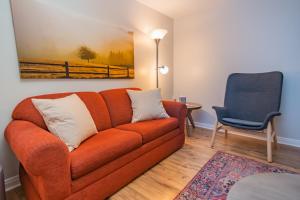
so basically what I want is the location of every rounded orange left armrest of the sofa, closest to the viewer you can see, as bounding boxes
[5,120,71,200]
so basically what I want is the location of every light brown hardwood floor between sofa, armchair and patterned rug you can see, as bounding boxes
[7,128,300,200]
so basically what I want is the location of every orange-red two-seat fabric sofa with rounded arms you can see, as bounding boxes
[5,88,186,200]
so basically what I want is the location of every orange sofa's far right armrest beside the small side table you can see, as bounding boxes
[162,101,187,133]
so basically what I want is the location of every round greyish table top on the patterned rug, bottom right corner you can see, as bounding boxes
[227,173,300,200]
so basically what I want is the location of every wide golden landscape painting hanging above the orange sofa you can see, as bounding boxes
[11,0,134,79]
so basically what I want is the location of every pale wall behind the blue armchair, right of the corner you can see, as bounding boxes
[174,0,300,141]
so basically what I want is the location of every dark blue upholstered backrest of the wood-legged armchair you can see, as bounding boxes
[224,72,283,122]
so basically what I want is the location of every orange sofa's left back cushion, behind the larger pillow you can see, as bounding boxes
[12,92,111,131]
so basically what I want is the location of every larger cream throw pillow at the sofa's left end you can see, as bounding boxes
[32,94,98,151]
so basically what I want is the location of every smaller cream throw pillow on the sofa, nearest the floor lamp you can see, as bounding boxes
[127,89,169,123]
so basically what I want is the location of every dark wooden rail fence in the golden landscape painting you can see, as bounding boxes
[19,61,130,78]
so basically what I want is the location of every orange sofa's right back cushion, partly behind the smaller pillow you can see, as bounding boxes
[100,88,141,127]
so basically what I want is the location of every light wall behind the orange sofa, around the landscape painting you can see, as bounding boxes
[0,0,173,178]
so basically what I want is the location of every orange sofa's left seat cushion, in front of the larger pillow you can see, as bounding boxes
[70,128,142,179]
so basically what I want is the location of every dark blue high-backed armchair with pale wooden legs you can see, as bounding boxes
[211,72,283,162]
